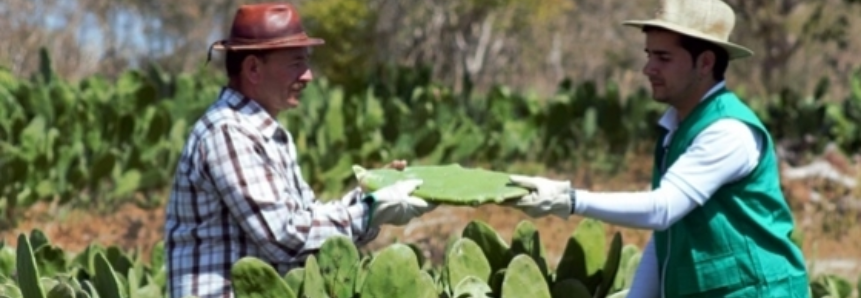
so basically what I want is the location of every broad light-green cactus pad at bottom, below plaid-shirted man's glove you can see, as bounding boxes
[360,243,437,298]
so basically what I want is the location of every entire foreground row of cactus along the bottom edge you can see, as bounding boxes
[0,225,861,298]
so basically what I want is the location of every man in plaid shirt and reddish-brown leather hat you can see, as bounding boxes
[165,3,435,298]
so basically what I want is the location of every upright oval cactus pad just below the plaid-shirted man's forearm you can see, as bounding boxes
[317,236,359,298]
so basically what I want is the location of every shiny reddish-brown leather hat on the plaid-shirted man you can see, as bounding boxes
[210,3,324,51]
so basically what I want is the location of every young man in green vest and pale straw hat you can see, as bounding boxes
[504,0,808,298]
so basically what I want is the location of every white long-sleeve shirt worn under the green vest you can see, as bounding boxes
[574,82,762,298]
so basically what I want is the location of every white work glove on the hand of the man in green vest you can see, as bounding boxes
[506,175,571,219]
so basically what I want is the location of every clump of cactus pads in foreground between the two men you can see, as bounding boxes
[234,221,636,298]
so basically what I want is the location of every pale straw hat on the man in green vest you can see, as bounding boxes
[622,0,753,59]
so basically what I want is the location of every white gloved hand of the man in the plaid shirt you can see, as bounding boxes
[366,179,436,227]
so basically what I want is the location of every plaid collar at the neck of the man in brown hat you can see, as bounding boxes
[218,87,283,137]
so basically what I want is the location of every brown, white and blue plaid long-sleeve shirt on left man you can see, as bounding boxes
[165,88,379,298]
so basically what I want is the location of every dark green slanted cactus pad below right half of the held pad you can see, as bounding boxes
[461,220,512,272]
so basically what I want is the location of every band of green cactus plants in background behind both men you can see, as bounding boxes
[0,51,861,228]
